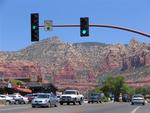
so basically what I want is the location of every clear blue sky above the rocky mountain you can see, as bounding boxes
[0,0,150,51]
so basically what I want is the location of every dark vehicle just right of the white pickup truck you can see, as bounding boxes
[88,93,102,103]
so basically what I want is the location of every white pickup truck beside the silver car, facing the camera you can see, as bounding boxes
[59,90,84,105]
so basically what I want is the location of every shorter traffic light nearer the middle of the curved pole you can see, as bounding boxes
[80,17,89,37]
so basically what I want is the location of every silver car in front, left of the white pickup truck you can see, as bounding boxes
[32,93,58,108]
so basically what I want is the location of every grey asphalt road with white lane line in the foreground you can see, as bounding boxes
[0,103,150,113]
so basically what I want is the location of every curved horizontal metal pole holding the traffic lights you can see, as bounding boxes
[39,24,150,38]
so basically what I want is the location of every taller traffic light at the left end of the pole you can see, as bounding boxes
[31,13,39,42]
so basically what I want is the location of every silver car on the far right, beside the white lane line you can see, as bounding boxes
[131,94,145,105]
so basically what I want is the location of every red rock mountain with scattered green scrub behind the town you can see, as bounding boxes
[0,37,150,90]
